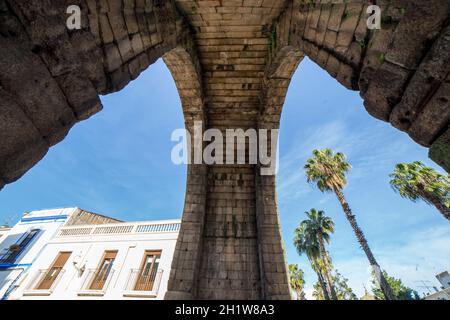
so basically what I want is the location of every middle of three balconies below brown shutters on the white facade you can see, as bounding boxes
[78,268,114,296]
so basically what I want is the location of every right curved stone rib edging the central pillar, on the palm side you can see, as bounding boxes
[251,46,304,299]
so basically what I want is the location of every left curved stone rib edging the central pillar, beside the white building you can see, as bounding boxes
[163,46,208,299]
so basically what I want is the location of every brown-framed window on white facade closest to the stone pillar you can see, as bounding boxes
[134,251,161,291]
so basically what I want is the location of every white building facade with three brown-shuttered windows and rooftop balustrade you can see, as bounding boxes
[8,220,181,300]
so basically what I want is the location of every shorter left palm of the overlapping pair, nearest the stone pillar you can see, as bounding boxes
[294,225,330,300]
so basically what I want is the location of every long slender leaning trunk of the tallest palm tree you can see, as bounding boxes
[334,188,397,300]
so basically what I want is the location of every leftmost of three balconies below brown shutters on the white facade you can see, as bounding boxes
[23,268,65,296]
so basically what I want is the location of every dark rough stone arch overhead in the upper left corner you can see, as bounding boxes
[0,0,185,189]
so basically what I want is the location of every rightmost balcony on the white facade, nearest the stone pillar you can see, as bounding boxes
[123,269,163,298]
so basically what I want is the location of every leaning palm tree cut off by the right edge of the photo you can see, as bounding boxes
[389,161,450,221]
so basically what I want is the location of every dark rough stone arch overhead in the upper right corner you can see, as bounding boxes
[275,0,450,171]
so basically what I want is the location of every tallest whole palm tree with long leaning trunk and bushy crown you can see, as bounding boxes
[304,149,395,300]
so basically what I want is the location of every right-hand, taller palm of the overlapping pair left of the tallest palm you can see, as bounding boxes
[300,209,337,300]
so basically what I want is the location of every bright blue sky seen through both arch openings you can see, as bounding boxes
[0,59,450,295]
